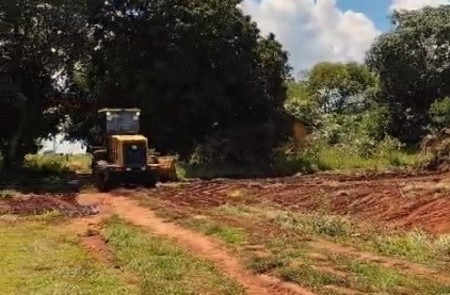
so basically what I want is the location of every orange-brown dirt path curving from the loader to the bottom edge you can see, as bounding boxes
[78,194,314,295]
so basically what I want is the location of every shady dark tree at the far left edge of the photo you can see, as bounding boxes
[0,0,88,169]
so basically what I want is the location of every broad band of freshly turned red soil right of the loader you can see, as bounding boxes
[134,174,450,234]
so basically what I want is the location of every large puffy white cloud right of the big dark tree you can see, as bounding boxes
[241,0,380,73]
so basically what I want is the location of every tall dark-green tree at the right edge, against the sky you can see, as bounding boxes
[367,5,450,143]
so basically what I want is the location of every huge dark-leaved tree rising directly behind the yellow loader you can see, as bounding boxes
[70,0,290,162]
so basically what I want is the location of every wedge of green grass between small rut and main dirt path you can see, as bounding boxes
[106,217,243,295]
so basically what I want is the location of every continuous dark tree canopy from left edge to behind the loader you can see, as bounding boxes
[0,0,290,169]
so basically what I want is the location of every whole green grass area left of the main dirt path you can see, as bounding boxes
[0,214,242,295]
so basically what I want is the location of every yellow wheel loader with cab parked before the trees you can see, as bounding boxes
[91,109,176,191]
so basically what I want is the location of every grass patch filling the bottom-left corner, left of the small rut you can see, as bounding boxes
[0,216,137,295]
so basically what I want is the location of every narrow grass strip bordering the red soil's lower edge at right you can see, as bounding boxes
[260,210,450,267]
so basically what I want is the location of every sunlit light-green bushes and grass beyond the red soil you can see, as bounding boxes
[278,108,415,173]
